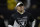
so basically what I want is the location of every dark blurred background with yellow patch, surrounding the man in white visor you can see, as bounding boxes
[0,0,40,27]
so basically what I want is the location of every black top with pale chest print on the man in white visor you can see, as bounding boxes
[9,11,34,27]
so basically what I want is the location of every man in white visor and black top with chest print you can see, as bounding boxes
[8,2,34,27]
